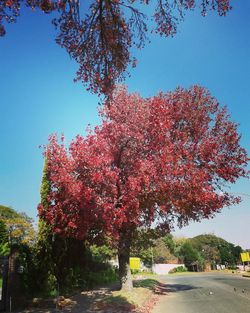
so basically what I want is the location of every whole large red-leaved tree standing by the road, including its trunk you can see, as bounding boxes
[39,86,248,289]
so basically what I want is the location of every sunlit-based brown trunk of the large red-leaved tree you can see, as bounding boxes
[118,232,133,291]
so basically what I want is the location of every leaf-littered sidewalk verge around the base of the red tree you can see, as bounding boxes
[16,278,162,313]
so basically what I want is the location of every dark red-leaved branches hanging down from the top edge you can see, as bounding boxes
[0,0,231,95]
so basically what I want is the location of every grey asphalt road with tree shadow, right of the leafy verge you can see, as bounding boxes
[153,273,250,313]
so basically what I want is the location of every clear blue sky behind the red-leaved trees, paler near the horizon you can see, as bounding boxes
[0,0,250,248]
